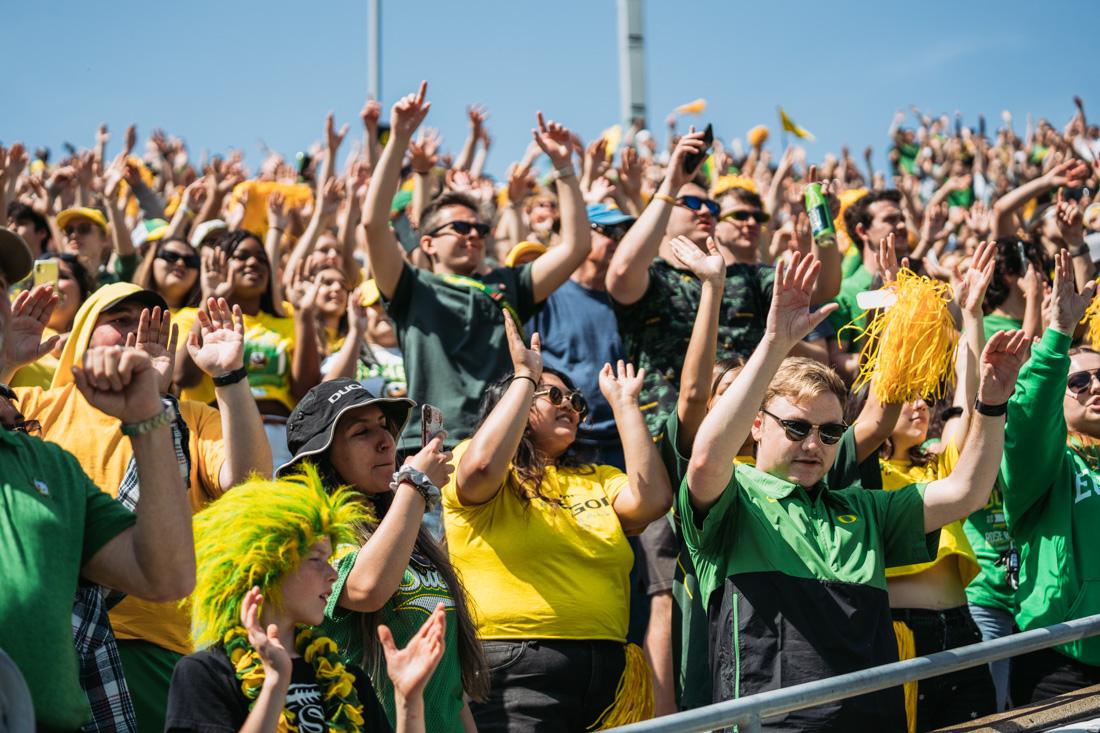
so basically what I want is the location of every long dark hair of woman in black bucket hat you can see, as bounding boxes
[305,453,488,701]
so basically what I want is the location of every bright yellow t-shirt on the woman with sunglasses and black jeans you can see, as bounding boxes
[442,440,634,642]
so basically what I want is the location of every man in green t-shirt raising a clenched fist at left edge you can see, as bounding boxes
[0,228,195,731]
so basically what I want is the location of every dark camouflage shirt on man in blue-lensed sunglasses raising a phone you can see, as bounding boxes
[615,258,776,436]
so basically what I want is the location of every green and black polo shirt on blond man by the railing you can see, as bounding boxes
[678,464,939,730]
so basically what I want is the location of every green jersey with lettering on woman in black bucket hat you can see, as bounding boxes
[321,539,465,733]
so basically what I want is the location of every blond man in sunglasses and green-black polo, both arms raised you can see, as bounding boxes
[678,253,1027,731]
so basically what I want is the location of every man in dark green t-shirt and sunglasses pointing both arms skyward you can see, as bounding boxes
[363,83,592,451]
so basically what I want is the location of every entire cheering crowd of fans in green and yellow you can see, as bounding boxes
[0,85,1100,732]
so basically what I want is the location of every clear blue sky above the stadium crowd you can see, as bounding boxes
[0,0,1100,175]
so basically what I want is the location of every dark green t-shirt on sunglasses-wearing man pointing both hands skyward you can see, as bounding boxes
[385,259,536,450]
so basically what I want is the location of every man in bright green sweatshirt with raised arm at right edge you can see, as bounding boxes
[1001,250,1100,704]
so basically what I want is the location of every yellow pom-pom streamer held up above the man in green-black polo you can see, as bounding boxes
[842,269,959,404]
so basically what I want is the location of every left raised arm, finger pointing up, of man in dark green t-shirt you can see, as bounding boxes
[363,81,431,299]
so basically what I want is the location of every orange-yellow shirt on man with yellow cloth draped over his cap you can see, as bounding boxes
[15,382,226,654]
